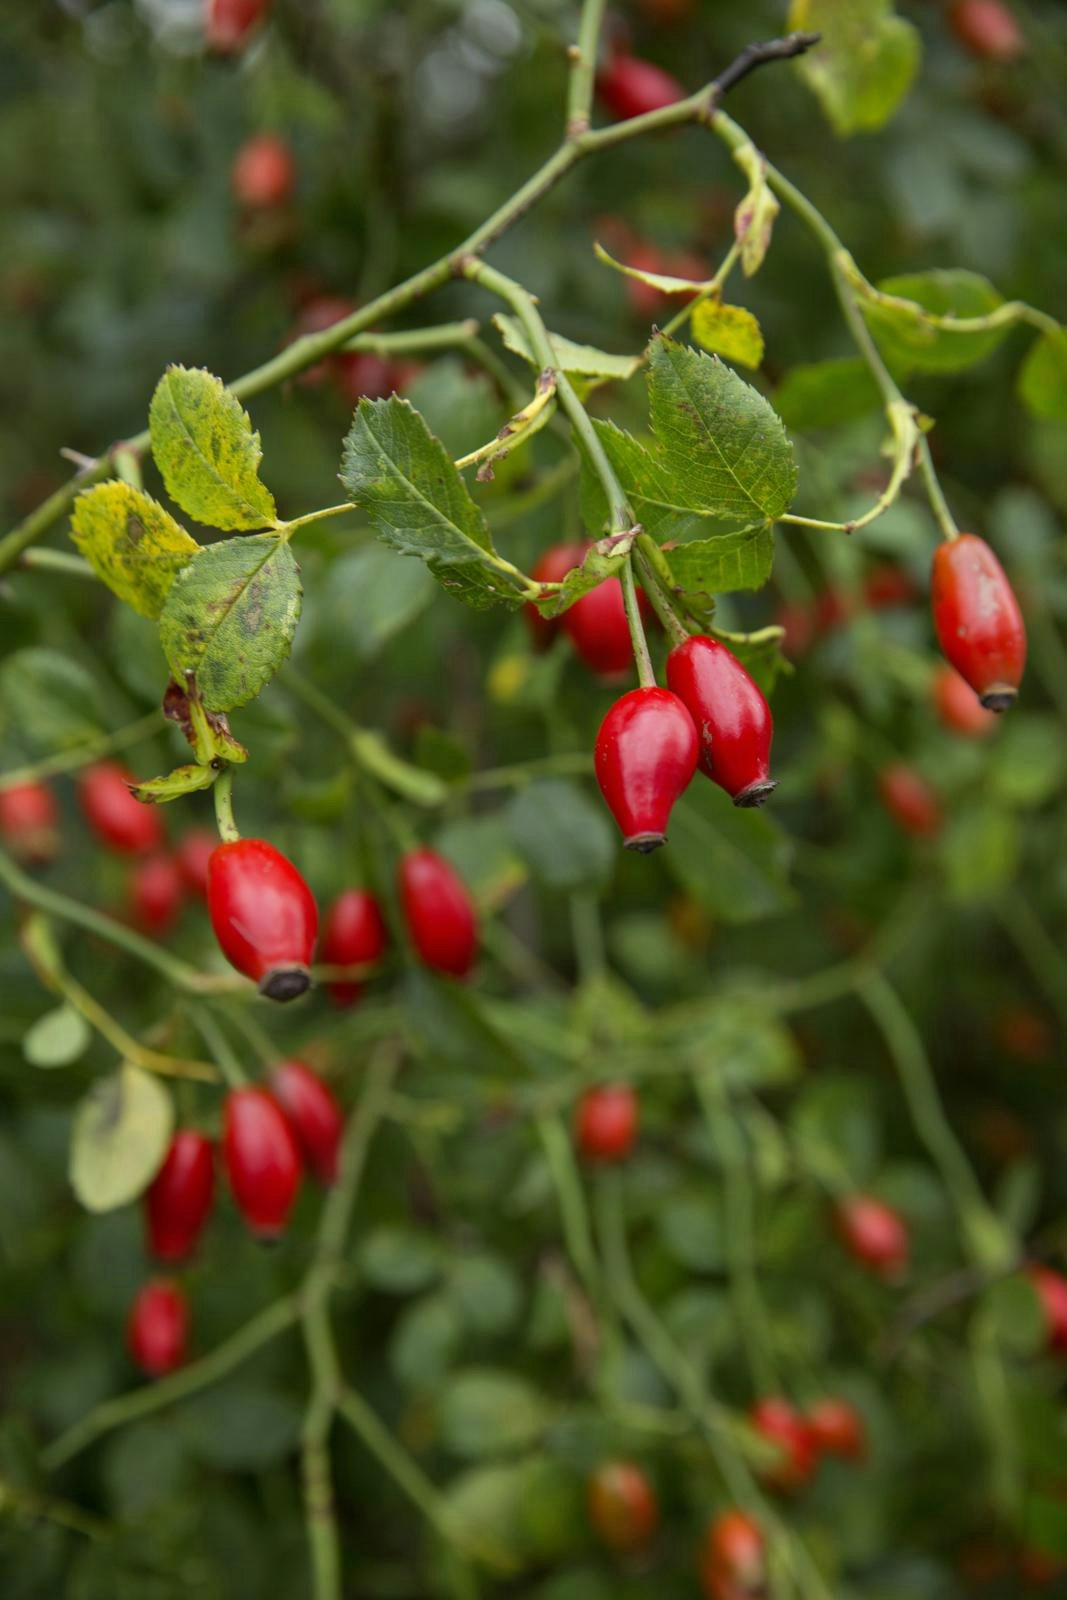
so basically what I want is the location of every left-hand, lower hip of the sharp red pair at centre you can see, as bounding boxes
[595,688,699,854]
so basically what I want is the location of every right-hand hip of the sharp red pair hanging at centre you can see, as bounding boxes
[667,635,777,806]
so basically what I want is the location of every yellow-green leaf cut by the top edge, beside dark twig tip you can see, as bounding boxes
[789,0,921,136]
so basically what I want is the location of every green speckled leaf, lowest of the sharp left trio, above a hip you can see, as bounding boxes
[160,538,301,710]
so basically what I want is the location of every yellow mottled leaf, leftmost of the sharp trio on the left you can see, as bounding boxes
[70,480,200,618]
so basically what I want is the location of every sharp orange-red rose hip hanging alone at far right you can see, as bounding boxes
[929,533,1027,710]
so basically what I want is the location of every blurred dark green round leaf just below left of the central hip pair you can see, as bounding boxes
[507,778,616,893]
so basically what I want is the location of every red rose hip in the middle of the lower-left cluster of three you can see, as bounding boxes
[222,1088,301,1238]
